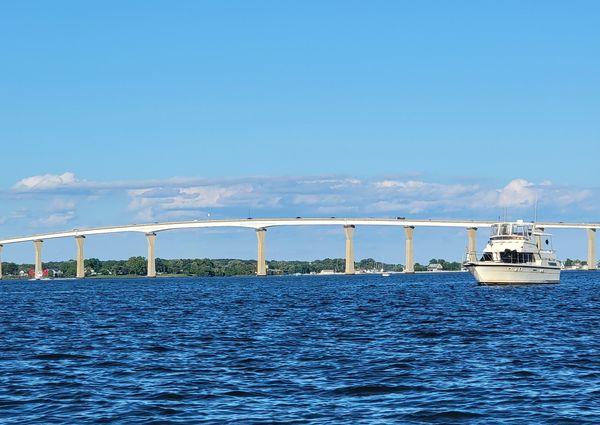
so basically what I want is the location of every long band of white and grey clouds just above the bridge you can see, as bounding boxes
[4,172,600,227]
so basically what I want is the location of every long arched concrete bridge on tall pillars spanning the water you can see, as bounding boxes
[0,217,600,278]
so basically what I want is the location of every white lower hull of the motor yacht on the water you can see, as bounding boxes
[466,262,560,285]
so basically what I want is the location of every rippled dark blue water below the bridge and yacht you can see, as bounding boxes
[0,272,600,424]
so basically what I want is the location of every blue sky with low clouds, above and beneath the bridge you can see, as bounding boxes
[0,0,600,263]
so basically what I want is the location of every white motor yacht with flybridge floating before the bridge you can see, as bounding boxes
[464,220,561,284]
